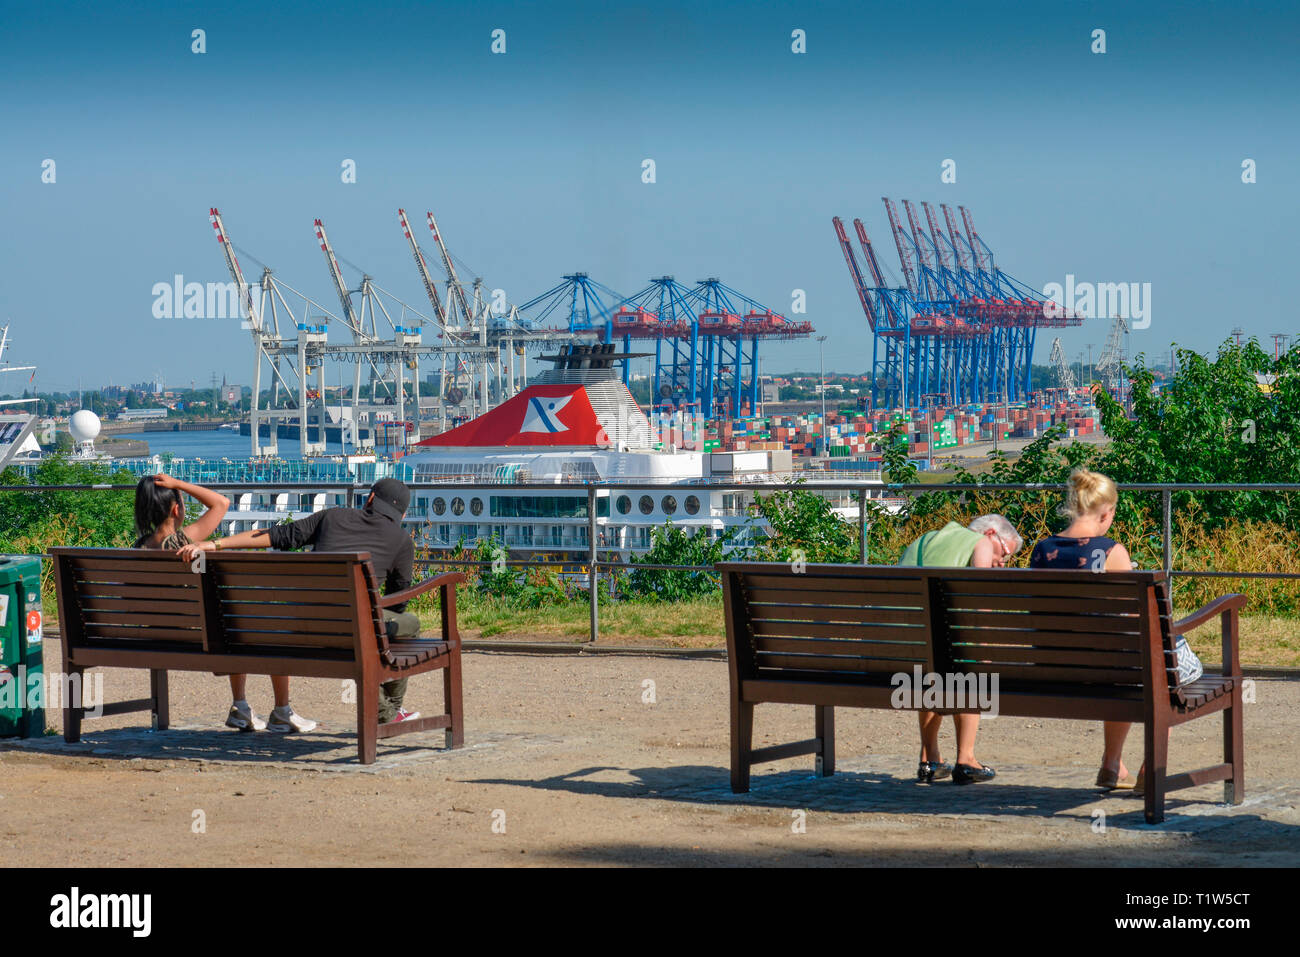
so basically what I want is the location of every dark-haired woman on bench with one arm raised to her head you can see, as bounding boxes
[135,475,316,733]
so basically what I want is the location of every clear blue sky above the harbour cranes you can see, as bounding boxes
[0,0,1300,389]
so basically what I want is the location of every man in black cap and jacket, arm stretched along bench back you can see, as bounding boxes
[181,479,420,724]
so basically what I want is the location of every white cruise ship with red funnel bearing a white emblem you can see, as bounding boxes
[169,345,891,560]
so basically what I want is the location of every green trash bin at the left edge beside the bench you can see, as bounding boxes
[0,555,47,737]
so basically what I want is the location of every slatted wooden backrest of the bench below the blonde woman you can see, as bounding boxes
[718,563,1173,694]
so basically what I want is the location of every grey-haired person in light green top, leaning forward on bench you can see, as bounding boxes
[898,515,1024,784]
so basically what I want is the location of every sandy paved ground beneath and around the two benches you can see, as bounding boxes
[0,642,1300,867]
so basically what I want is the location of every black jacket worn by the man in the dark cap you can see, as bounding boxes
[267,507,415,611]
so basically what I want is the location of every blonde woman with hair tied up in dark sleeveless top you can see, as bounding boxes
[1030,468,1203,793]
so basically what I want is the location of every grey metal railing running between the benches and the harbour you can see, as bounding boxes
[0,475,1300,644]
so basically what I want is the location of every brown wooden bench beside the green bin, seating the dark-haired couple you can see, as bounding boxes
[51,549,464,765]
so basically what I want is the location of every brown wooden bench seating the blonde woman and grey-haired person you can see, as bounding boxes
[716,563,1247,823]
